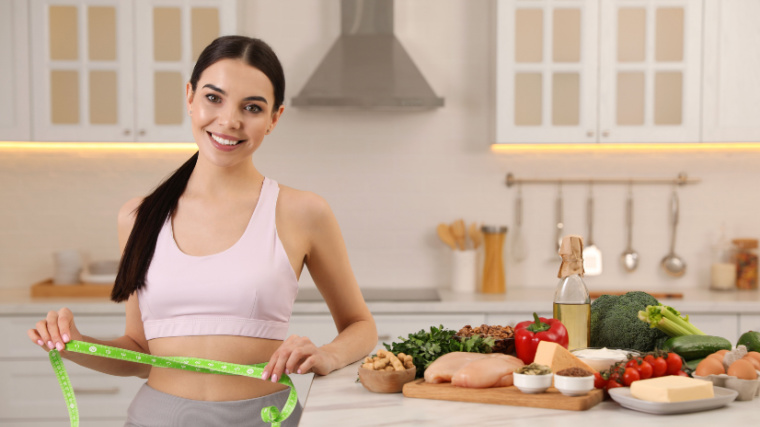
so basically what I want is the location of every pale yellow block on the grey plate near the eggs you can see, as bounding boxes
[631,375,715,402]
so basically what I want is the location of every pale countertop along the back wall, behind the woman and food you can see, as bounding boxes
[0,288,760,315]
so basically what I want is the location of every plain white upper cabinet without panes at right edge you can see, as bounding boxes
[702,0,760,142]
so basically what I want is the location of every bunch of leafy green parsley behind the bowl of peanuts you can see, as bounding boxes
[383,325,494,378]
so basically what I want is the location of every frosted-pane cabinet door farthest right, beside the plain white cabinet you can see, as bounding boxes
[599,0,702,142]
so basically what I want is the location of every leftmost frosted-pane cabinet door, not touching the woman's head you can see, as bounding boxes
[31,0,134,141]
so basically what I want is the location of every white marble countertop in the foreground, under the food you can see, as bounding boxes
[299,362,760,427]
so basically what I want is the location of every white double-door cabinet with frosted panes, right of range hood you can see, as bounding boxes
[495,0,702,143]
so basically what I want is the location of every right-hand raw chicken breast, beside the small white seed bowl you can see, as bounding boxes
[451,354,524,388]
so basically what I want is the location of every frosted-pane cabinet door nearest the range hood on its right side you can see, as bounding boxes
[495,0,598,143]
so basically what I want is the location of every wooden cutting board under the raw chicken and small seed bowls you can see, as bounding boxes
[403,378,604,411]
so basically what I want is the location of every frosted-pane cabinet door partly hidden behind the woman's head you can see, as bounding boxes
[135,0,237,142]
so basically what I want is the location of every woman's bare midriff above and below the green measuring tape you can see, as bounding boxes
[148,335,287,401]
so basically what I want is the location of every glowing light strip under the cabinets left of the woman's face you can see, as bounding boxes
[0,141,198,151]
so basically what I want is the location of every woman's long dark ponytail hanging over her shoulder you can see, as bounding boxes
[111,152,198,302]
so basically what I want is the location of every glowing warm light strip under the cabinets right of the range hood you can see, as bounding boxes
[491,142,760,153]
